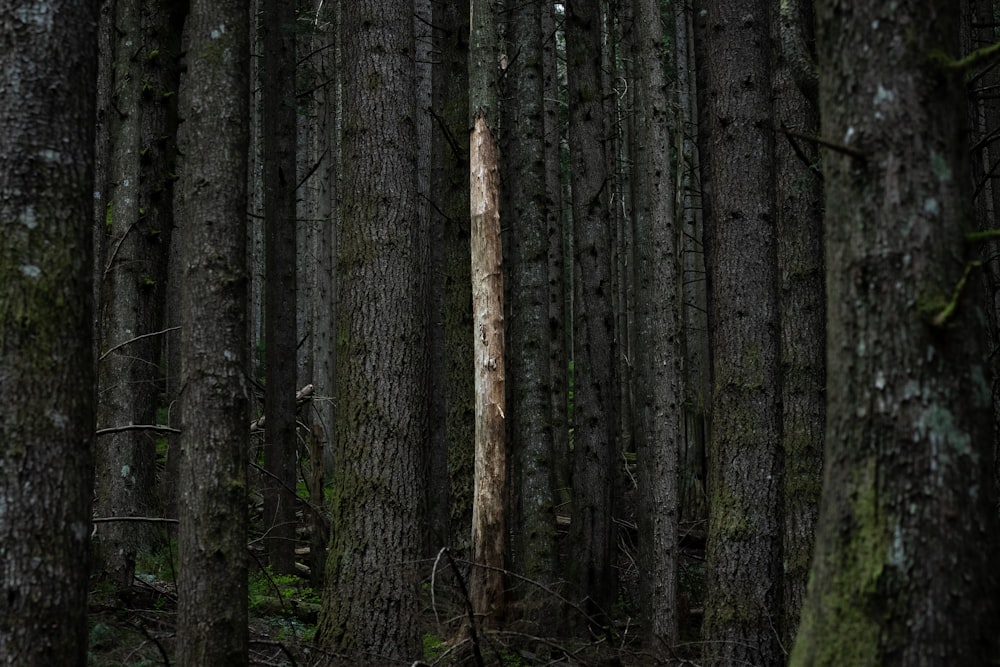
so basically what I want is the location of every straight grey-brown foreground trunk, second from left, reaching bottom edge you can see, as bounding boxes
[177,0,250,665]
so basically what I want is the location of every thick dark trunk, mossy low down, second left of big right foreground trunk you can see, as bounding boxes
[699,0,784,665]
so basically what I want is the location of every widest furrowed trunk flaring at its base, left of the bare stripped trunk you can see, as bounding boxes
[317,0,427,664]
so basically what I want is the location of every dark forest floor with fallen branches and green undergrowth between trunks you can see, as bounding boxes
[88,524,703,667]
